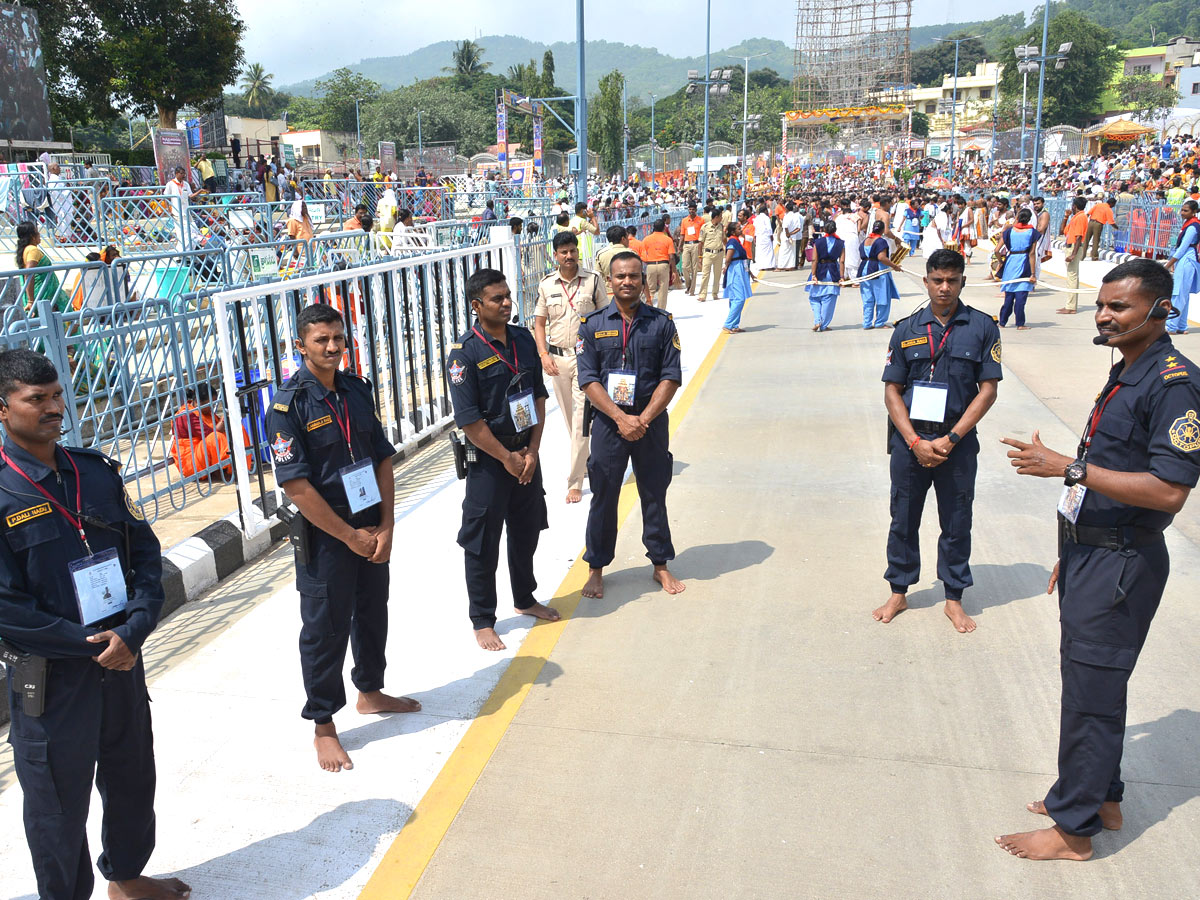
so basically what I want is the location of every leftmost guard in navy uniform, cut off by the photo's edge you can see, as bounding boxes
[0,349,188,900]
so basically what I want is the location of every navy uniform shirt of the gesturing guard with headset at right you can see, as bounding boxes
[1076,335,1200,530]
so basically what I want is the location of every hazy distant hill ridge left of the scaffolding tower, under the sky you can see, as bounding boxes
[280,35,794,96]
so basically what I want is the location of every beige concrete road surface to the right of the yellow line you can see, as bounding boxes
[409,266,1200,900]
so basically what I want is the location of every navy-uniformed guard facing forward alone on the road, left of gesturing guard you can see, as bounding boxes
[871,250,1003,634]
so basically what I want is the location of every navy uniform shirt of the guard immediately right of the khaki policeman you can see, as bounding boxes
[576,300,683,415]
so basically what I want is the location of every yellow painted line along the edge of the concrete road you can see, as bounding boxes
[359,331,730,900]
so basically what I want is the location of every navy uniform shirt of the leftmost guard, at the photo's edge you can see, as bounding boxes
[0,442,164,659]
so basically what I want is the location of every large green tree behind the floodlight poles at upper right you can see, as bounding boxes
[1000,6,1122,127]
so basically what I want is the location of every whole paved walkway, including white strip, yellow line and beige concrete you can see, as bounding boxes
[0,260,1200,900]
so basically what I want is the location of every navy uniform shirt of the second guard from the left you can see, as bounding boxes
[266,364,396,514]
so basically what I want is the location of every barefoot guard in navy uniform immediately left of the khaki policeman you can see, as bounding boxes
[446,269,559,650]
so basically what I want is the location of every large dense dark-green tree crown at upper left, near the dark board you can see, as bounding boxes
[90,0,246,128]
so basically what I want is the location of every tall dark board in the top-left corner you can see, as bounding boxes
[0,4,54,142]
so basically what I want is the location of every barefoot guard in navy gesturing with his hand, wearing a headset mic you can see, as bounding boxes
[996,259,1200,859]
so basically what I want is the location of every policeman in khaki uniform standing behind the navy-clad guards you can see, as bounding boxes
[533,232,604,503]
